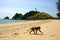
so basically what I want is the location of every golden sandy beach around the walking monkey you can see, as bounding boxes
[0,20,60,40]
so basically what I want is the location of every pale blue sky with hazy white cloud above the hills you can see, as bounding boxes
[0,0,58,19]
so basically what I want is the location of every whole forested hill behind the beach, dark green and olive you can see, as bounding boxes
[12,11,52,20]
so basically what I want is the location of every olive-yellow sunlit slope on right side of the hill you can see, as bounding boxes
[27,12,52,20]
